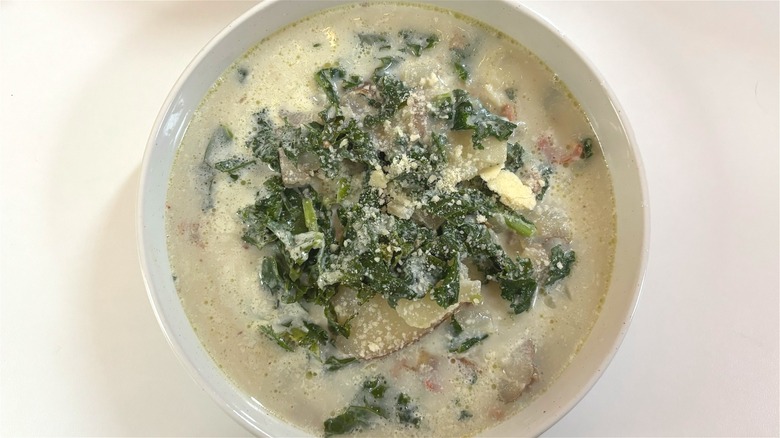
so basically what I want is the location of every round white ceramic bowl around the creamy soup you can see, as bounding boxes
[138,0,649,436]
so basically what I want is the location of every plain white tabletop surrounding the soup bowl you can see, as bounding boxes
[0,0,780,436]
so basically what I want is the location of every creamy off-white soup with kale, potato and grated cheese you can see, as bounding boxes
[166,3,615,437]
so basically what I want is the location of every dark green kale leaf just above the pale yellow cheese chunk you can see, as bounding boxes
[452,90,517,149]
